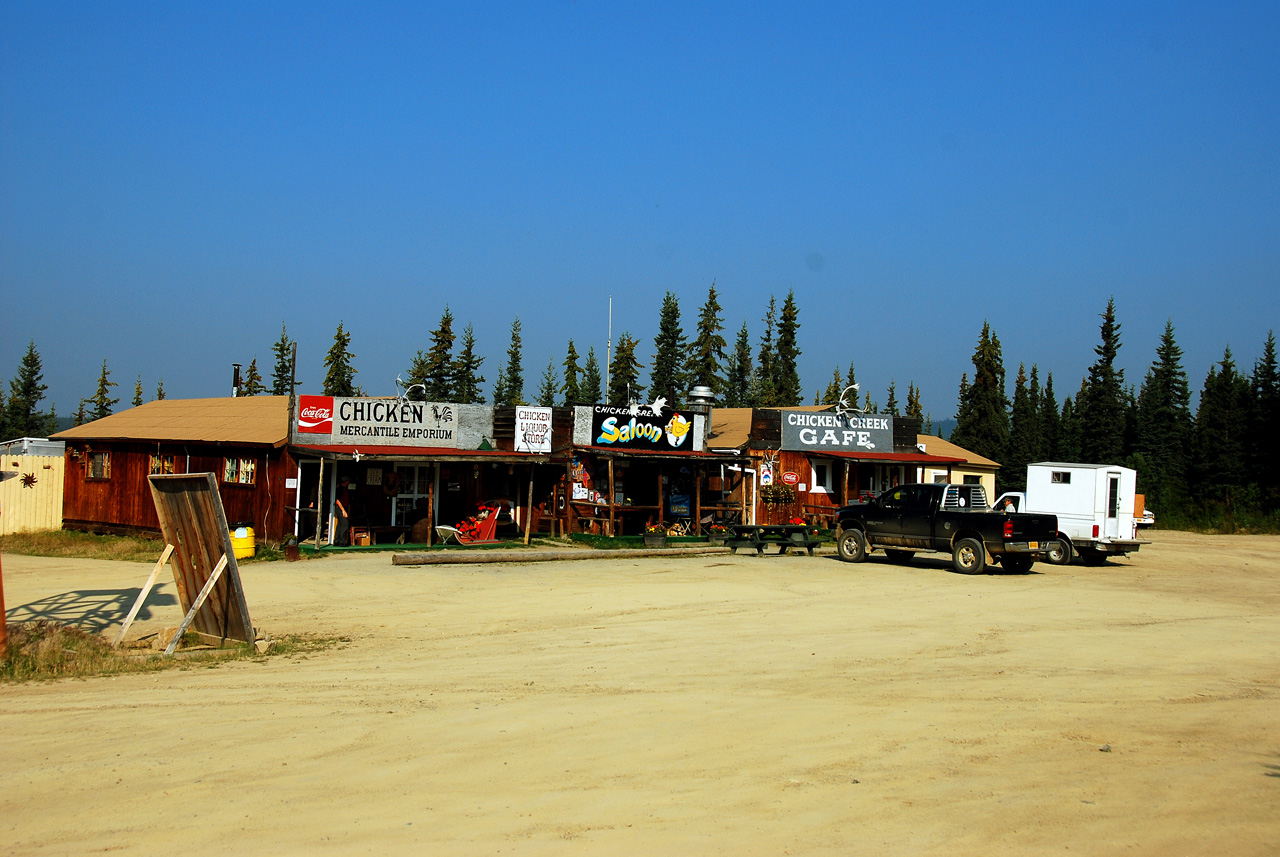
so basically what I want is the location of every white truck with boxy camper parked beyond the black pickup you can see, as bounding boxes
[996,462,1151,565]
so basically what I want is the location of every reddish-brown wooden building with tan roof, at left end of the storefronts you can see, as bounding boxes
[52,395,297,541]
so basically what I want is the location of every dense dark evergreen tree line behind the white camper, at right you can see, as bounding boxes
[951,298,1280,531]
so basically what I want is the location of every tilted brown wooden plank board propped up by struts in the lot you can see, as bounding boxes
[148,473,253,643]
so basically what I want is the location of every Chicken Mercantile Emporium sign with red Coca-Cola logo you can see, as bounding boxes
[297,395,458,448]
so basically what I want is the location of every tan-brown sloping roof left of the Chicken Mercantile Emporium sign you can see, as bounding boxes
[52,395,289,446]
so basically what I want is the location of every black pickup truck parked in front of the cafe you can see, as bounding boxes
[836,484,1057,574]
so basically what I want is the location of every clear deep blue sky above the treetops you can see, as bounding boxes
[0,0,1280,418]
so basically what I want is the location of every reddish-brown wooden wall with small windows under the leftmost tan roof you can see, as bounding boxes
[63,440,297,541]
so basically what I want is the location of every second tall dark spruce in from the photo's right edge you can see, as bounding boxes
[1192,348,1252,527]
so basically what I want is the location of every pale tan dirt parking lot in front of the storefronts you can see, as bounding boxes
[0,532,1280,856]
